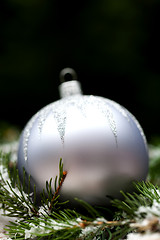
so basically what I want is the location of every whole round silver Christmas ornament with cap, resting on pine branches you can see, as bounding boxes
[18,69,148,205]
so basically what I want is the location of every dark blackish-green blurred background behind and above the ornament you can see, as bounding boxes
[0,0,160,141]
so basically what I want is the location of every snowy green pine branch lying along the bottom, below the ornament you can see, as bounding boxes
[4,209,120,240]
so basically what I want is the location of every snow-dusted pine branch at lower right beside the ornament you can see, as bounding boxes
[112,182,160,239]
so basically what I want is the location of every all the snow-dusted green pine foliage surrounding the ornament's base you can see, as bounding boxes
[0,142,160,240]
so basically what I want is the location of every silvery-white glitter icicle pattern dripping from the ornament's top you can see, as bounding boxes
[23,95,120,161]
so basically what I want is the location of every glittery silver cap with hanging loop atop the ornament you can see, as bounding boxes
[59,68,82,98]
